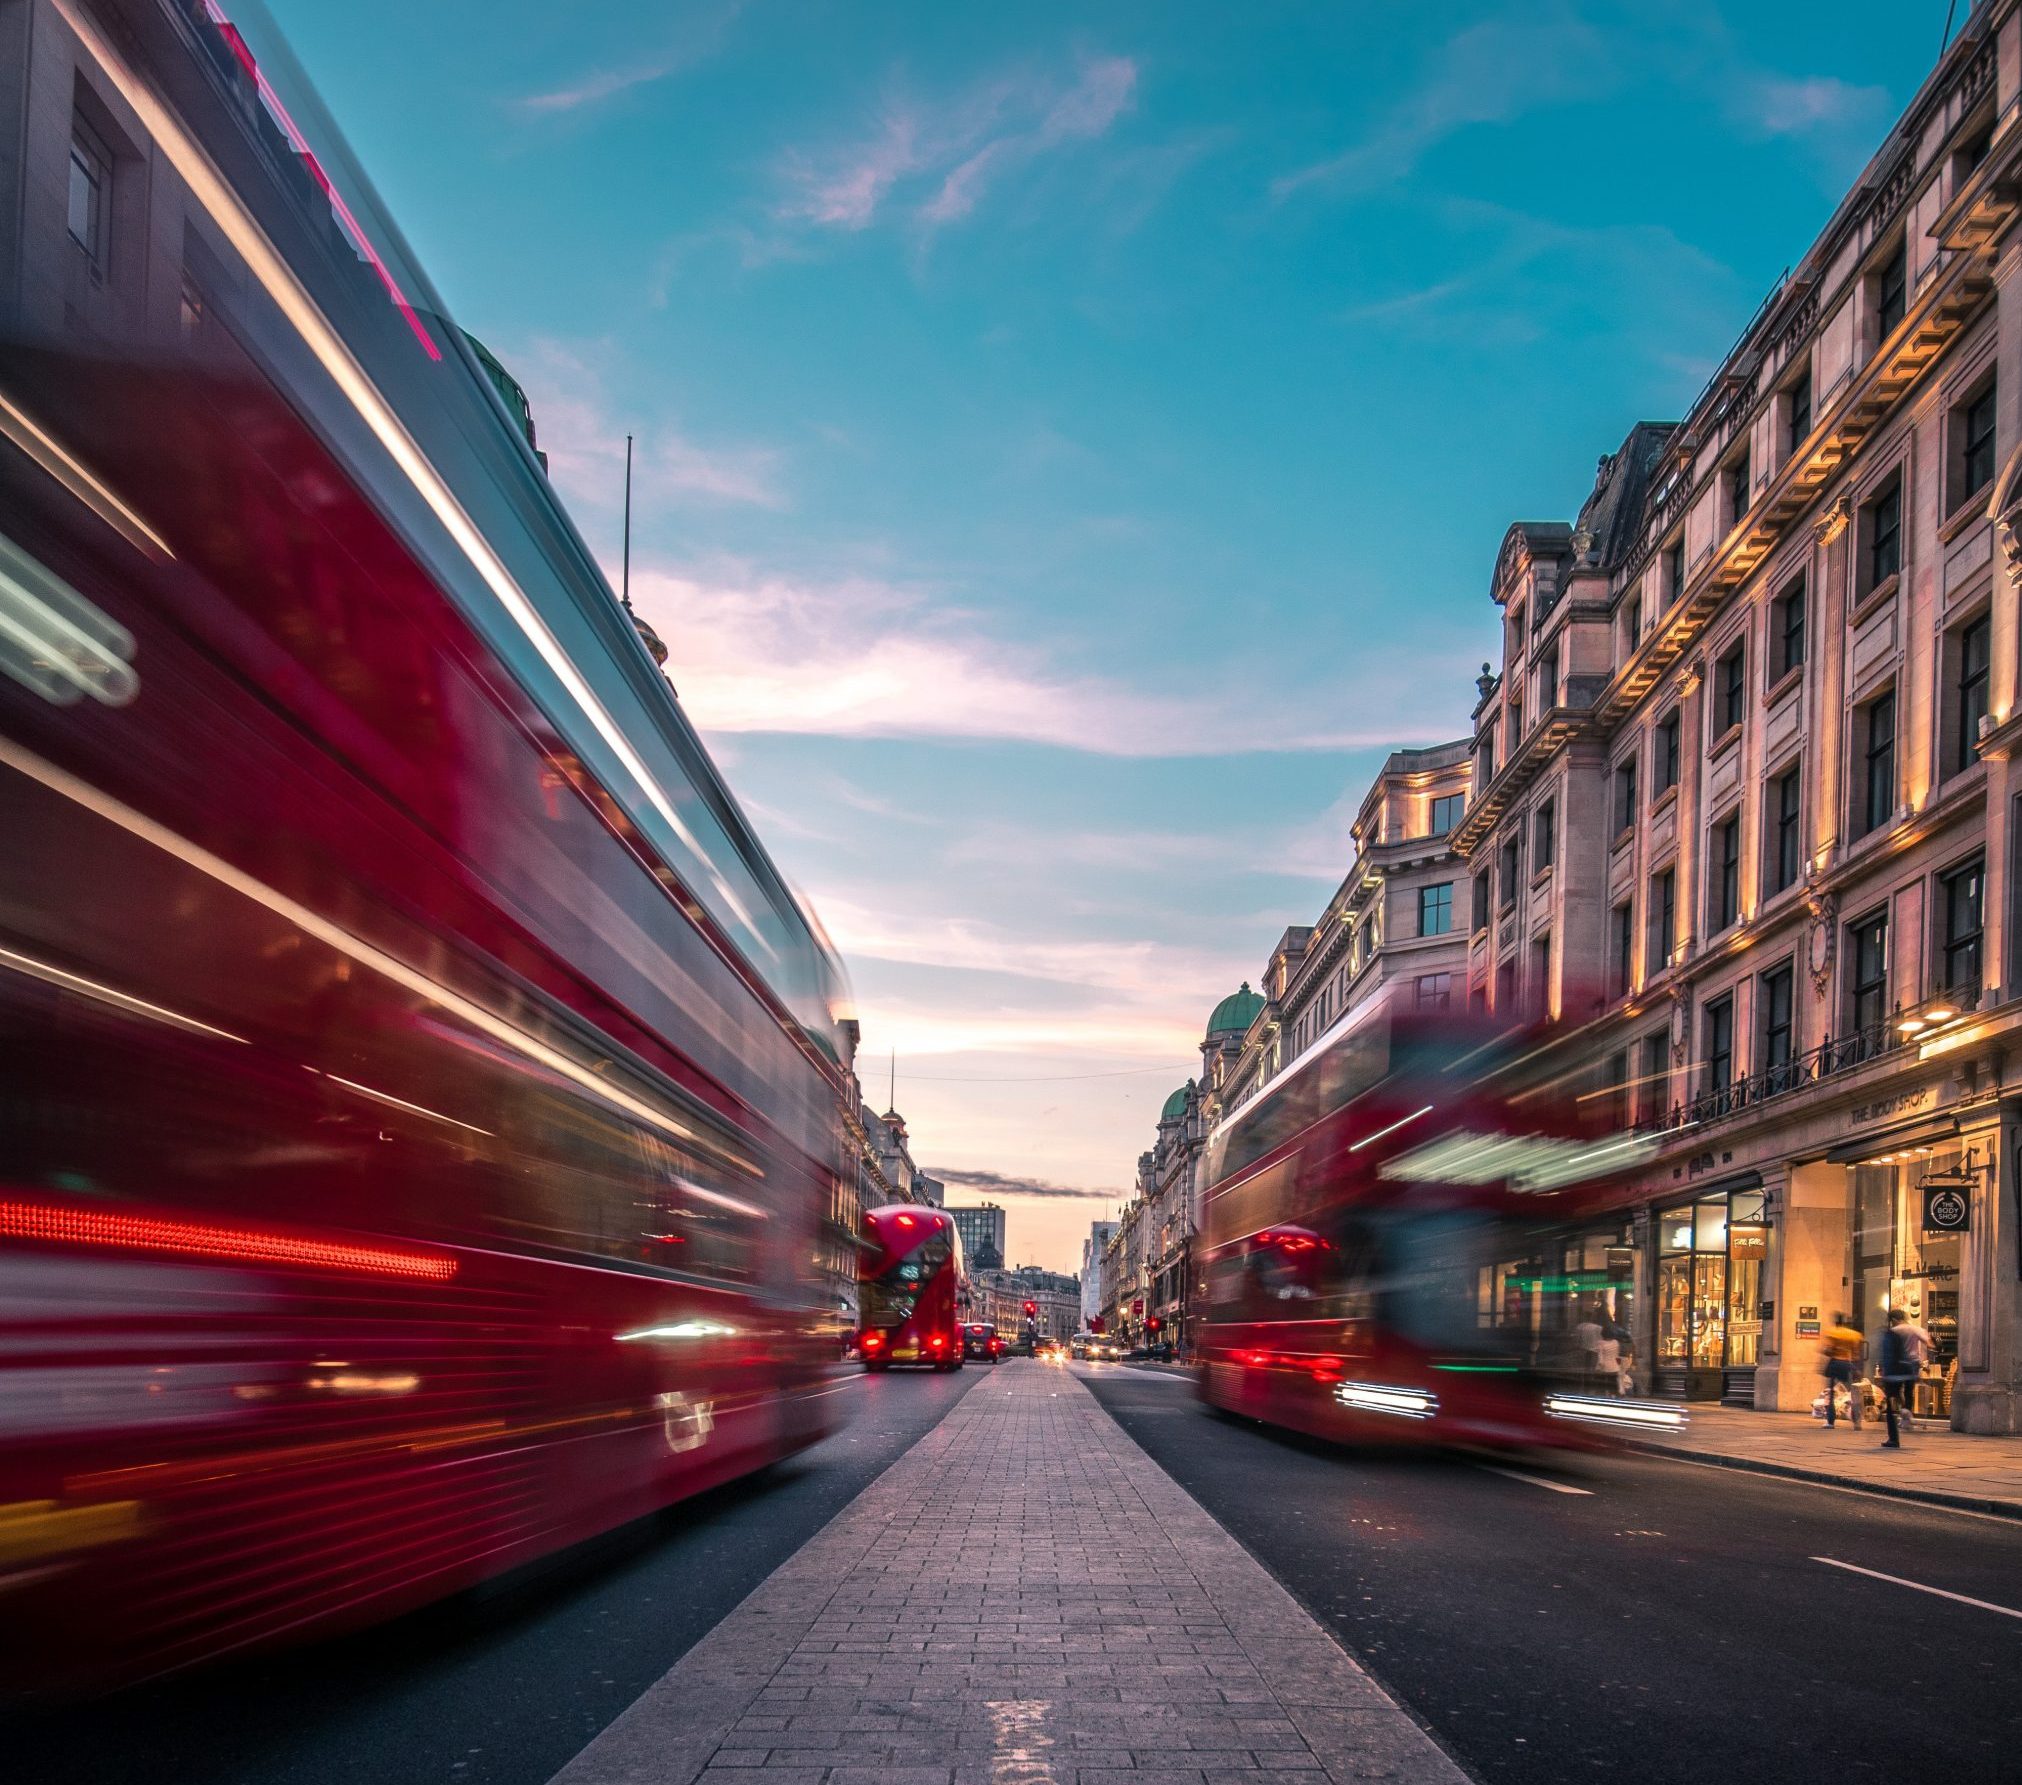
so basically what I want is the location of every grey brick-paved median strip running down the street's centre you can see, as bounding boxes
[554,1363,1464,1785]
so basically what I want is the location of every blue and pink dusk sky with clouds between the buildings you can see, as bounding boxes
[271,0,1963,1270]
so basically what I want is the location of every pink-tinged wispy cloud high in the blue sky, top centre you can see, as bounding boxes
[776,57,1138,230]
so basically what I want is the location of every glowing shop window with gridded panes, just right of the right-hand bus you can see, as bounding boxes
[1654,1177,1769,1407]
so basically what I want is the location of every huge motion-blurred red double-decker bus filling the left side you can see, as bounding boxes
[0,0,847,1688]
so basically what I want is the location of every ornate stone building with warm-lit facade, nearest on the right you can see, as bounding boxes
[1452,0,2022,1431]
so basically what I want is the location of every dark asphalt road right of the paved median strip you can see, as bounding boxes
[1076,1365,2022,1785]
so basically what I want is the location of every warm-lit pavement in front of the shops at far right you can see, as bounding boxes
[1636,1403,2022,1518]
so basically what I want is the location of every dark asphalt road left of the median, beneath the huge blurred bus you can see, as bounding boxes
[0,1369,981,1785]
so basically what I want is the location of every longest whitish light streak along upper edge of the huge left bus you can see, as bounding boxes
[53,0,778,960]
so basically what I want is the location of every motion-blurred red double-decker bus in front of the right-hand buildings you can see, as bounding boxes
[1201,999,1678,1445]
